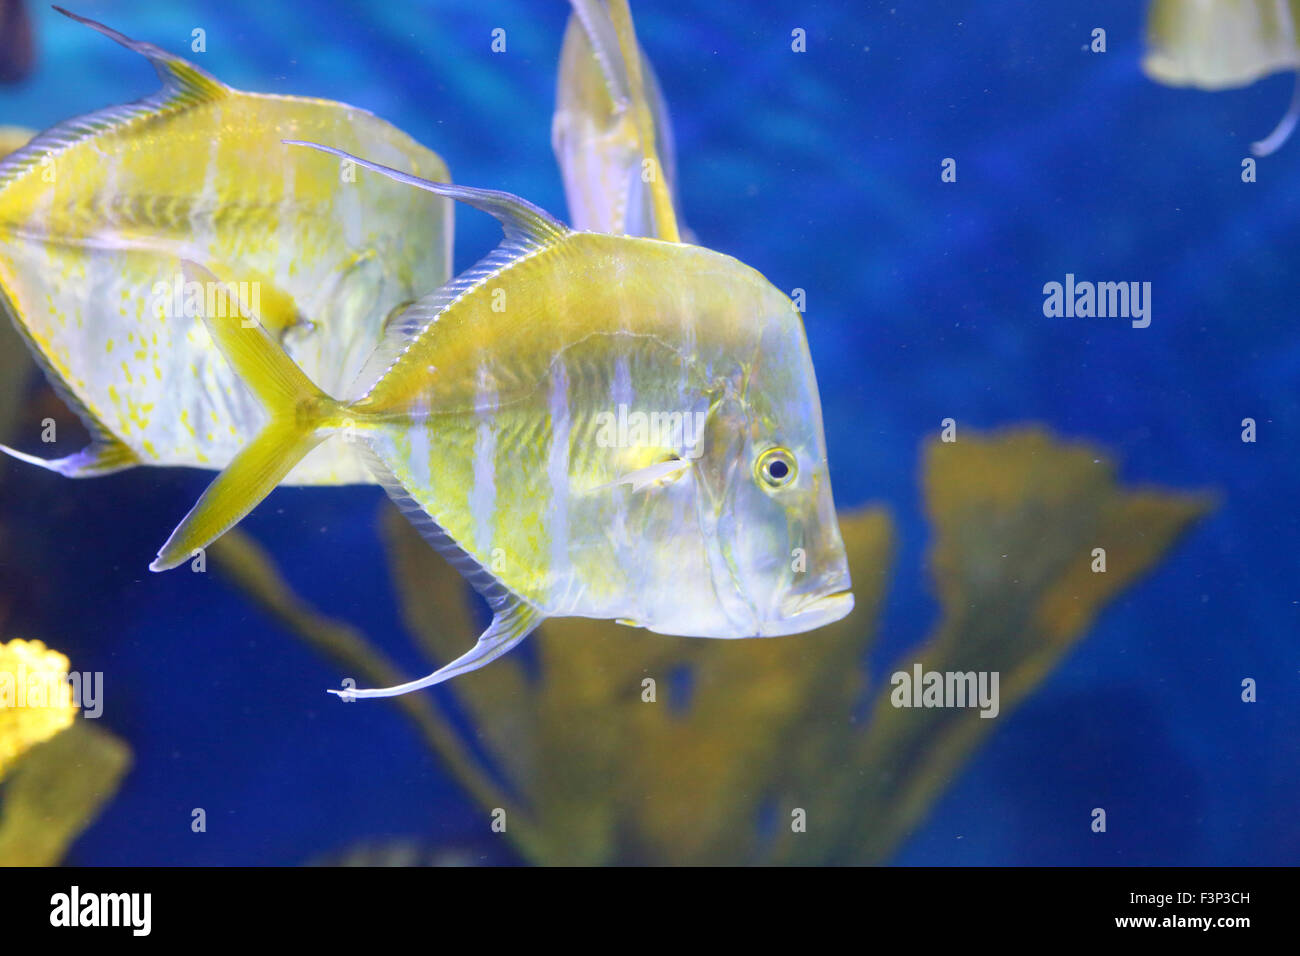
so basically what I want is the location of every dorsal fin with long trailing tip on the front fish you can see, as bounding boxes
[285,139,571,401]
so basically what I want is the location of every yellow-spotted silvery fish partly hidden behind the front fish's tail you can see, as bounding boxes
[0,12,452,484]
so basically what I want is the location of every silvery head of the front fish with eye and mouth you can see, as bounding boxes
[650,289,853,637]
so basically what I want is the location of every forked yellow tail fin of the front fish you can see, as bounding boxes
[150,261,348,571]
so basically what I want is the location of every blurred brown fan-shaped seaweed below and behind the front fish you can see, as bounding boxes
[211,427,1212,864]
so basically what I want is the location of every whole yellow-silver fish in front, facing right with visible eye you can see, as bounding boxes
[151,143,853,697]
